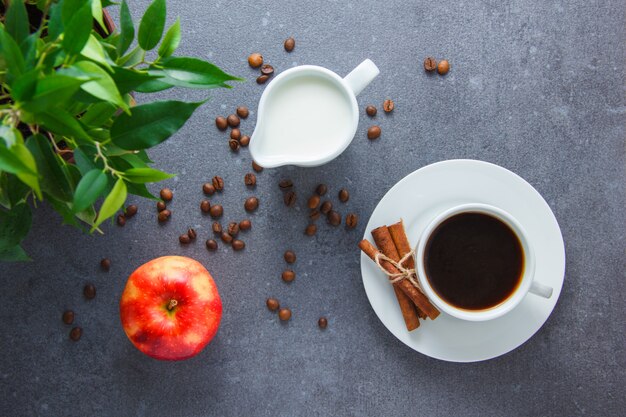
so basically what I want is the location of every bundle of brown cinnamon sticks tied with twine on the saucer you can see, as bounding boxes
[359,220,439,331]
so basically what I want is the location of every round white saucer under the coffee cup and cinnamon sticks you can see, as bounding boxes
[361,159,565,362]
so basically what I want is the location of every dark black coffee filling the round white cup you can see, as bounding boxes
[424,213,524,310]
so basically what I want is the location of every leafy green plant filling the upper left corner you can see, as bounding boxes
[0,0,240,260]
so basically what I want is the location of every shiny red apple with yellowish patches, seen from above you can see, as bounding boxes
[120,256,222,360]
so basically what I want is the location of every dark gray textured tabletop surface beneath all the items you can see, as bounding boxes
[0,0,626,417]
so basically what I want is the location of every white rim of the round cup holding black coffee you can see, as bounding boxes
[415,203,535,321]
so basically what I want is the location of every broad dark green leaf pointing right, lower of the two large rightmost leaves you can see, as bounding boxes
[111,101,204,150]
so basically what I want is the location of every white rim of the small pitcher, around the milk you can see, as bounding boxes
[250,65,359,168]
